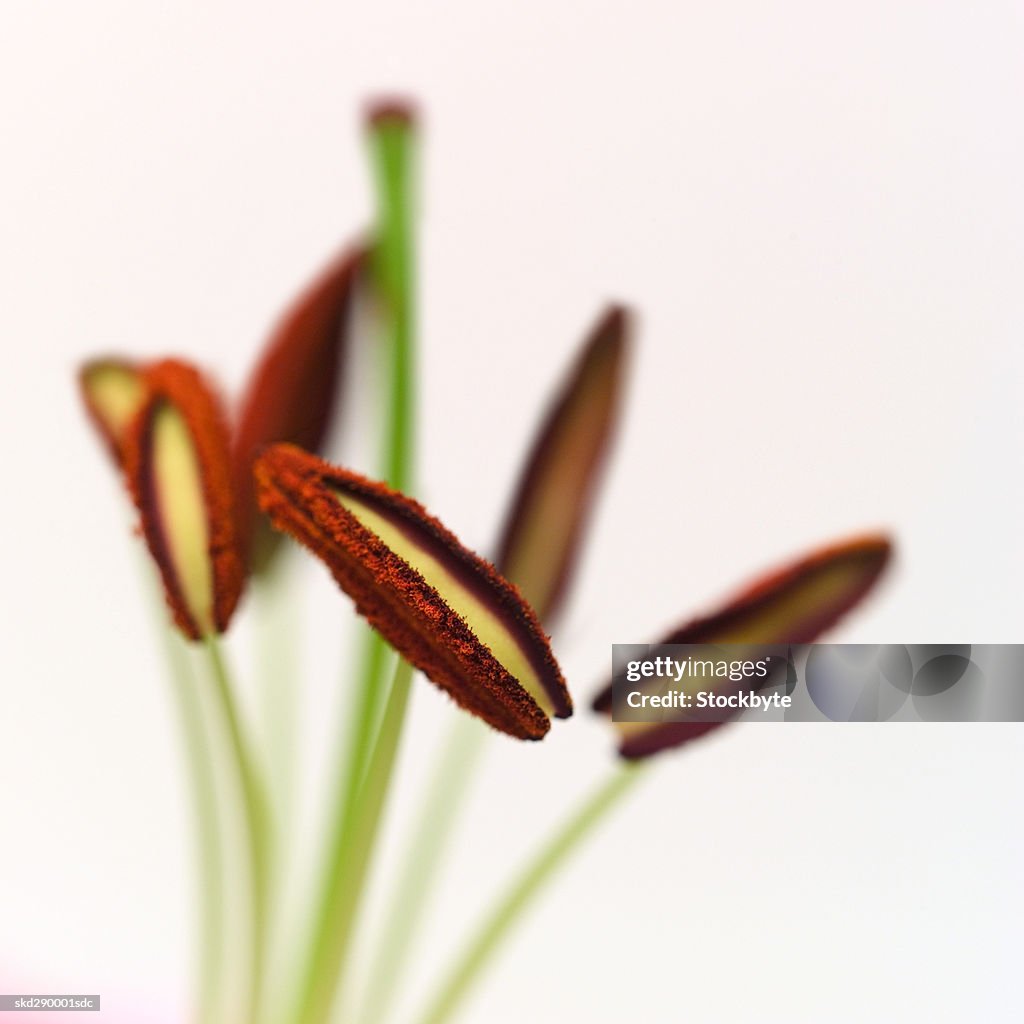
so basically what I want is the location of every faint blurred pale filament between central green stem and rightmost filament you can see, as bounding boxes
[358,711,488,1024]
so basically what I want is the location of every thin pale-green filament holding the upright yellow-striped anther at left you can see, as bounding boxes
[204,634,270,1024]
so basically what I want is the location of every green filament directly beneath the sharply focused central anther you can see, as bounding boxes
[298,660,413,1024]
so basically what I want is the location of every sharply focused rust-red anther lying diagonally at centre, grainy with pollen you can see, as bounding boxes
[256,444,572,739]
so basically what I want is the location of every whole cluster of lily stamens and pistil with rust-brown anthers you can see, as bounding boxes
[72,96,905,1024]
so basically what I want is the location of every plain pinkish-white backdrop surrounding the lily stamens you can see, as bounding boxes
[0,0,1024,1024]
